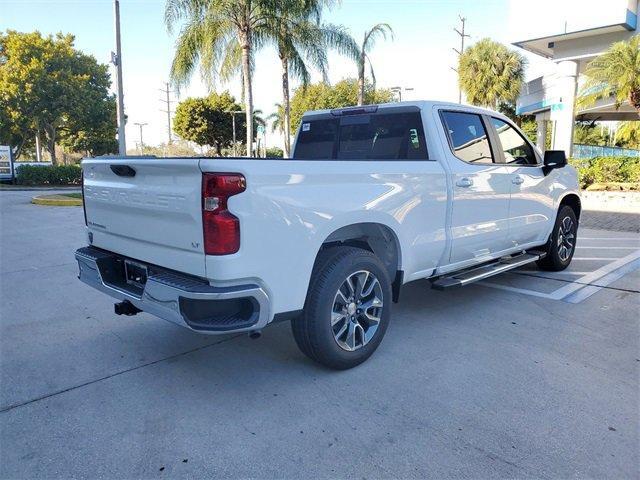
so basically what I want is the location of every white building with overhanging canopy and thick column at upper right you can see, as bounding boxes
[513,0,640,156]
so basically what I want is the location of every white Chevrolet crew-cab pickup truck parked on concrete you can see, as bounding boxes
[76,101,581,369]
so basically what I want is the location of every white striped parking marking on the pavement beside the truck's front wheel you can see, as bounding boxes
[479,232,640,303]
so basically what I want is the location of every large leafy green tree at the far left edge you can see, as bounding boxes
[0,30,116,164]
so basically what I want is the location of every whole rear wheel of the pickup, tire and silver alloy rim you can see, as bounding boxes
[292,247,391,370]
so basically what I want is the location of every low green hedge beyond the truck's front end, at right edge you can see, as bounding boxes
[569,157,640,189]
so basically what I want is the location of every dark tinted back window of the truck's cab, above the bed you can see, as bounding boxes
[294,111,427,160]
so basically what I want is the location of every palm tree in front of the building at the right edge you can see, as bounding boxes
[578,35,640,111]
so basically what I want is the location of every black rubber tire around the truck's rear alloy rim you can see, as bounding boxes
[291,247,391,370]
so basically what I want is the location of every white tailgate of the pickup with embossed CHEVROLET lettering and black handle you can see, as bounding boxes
[82,158,205,276]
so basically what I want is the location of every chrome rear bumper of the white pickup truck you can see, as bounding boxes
[76,247,269,334]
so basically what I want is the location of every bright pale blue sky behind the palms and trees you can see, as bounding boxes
[0,0,627,148]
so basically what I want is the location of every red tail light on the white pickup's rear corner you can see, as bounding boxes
[202,173,247,255]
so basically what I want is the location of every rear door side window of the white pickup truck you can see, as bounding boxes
[442,112,494,164]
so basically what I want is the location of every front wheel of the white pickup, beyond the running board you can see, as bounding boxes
[537,205,578,272]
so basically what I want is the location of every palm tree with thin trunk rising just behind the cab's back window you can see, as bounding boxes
[267,0,358,157]
